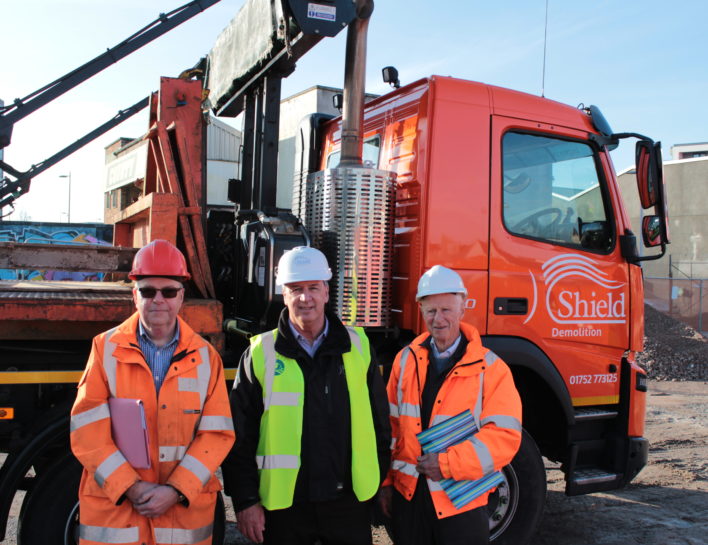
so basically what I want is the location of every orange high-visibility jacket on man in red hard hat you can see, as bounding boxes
[71,313,234,545]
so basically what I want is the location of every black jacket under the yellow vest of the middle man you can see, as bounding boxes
[222,308,391,511]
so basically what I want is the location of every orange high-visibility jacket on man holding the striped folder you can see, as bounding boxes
[384,323,521,518]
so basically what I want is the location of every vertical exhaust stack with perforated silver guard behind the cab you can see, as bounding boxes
[293,0,396,327]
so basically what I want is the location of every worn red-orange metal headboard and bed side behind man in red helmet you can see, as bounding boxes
[0,78,224,350]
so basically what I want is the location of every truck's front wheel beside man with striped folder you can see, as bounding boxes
[487,430,546,545]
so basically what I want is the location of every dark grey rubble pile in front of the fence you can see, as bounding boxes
[637,305,708,380]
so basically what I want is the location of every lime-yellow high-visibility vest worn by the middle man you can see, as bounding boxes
[251,326,379,510]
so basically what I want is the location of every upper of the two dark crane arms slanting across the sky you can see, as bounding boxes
[0,0,220,149]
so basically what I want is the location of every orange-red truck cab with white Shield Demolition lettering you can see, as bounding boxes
[313,76,660,543]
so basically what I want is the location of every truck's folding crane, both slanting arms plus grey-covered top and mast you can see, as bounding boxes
[0,0,360,217]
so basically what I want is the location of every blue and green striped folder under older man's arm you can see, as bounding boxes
[417,409,504,509]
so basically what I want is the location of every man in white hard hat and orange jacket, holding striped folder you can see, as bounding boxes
[380,265,521,545]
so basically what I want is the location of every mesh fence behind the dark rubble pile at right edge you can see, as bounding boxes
[644,277,708,336]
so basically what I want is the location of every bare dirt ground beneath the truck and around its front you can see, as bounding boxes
[226,378,708,545]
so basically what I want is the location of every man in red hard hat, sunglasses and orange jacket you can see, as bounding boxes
[71,240,234,545]
